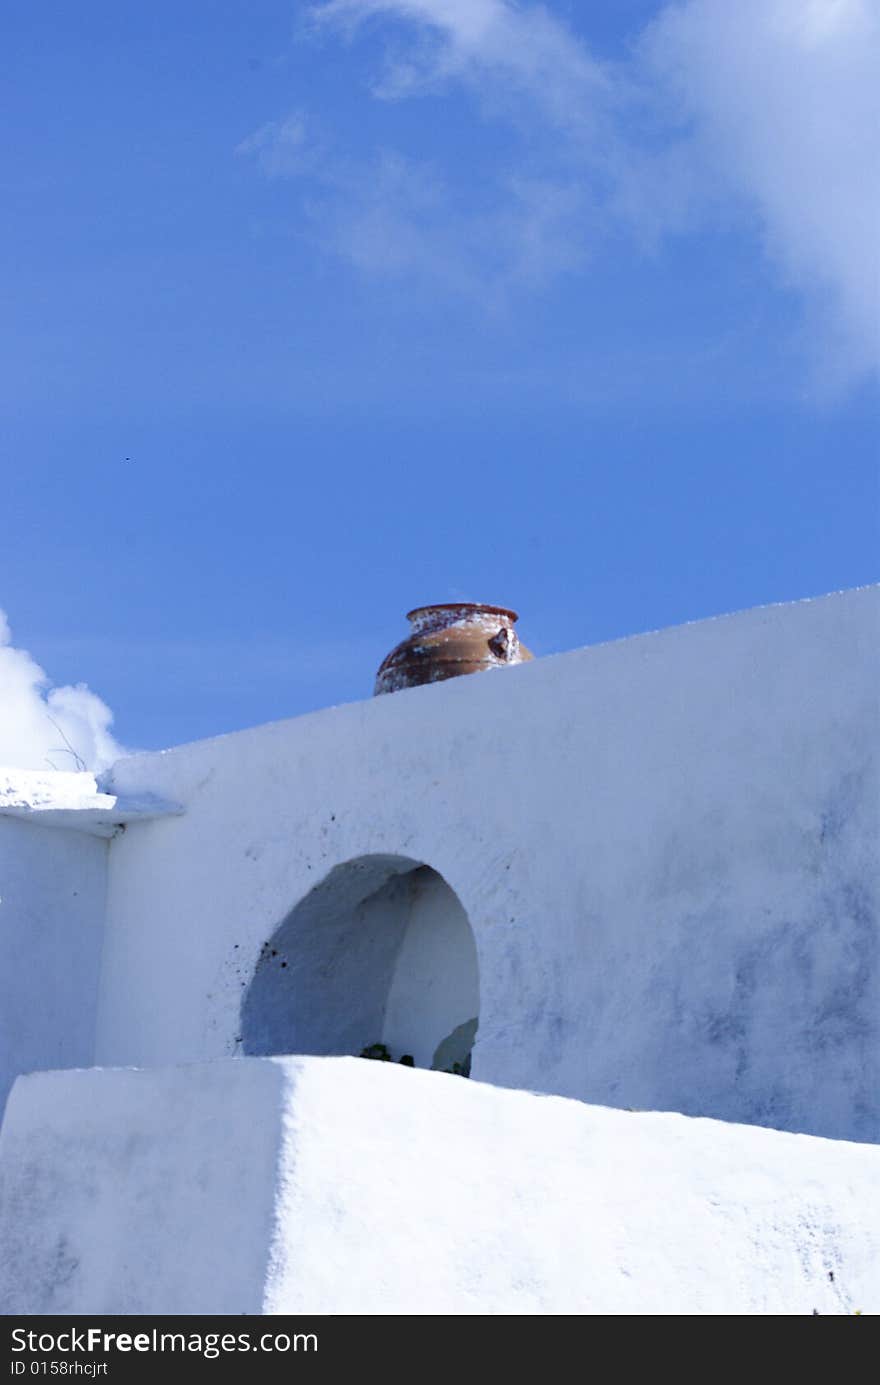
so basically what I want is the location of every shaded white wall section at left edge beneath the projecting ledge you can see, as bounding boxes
[0,817,108,1115]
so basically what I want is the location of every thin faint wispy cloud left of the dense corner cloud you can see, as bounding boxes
[243,0,622,297]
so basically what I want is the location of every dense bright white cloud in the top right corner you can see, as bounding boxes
[642,0,880,385]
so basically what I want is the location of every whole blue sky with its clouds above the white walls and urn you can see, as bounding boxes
[0,0,880,767]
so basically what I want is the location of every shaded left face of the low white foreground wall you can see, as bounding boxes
[0,1061,284,1314]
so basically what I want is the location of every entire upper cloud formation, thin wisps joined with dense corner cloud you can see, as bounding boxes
[240,0,880,377]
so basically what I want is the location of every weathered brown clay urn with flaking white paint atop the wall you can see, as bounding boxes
[374,601,534,697]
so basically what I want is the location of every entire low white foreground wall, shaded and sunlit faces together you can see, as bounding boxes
[0,1058,880,1314]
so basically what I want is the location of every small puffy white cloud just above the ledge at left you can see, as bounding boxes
[0,611,125,771]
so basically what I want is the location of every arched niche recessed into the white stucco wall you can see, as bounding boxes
[241,856,479,1071]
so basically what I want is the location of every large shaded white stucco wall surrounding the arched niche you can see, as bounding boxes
[97,589,880,1140]
